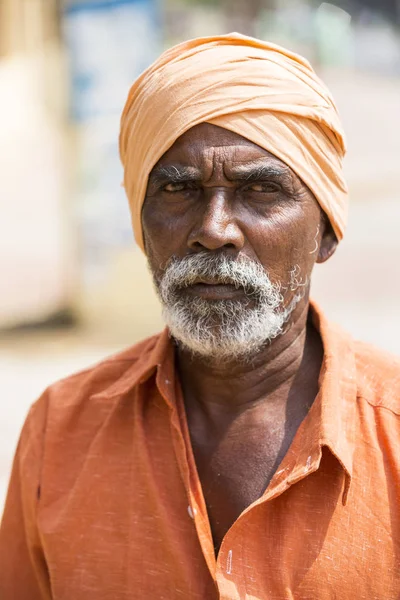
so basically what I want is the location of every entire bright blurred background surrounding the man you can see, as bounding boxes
[0,0,400,512]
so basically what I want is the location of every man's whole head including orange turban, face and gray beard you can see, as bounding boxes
[120,34,346,358]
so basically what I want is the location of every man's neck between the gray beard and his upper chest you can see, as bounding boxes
[177,302,322,417]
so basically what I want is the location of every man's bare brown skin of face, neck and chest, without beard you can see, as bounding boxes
[142,123,337,553]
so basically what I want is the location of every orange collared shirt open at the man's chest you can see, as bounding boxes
[0,308,400,600]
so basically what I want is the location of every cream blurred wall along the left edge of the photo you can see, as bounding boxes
[0,0,73,327]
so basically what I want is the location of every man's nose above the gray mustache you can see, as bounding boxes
[188,189,244,251]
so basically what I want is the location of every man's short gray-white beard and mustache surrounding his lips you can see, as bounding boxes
[154,253,303,361]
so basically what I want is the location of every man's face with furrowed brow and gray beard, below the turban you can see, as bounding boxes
[142,123,335,358]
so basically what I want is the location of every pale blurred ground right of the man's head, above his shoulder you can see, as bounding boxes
[313,72,400,354]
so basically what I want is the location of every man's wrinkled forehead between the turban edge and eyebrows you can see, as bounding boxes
[159,123,287,167]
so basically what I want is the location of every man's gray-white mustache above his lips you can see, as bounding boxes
[159,252,279,296]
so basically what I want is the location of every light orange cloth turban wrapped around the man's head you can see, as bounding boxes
[120,33,347,249]
